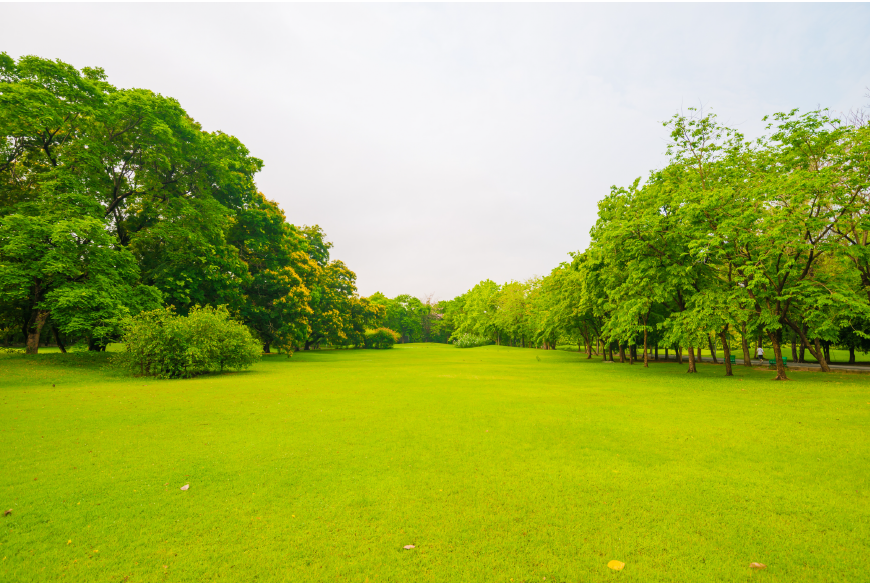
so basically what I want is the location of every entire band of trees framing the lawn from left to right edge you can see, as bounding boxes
[0,53,869,378]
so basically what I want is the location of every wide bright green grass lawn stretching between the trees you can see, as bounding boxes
[0,345,871,582]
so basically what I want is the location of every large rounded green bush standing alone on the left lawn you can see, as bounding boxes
[115,306,261,378]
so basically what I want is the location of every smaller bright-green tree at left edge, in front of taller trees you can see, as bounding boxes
[0,188,160,354]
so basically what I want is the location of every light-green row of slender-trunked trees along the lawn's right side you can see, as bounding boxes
[440,109,869,379]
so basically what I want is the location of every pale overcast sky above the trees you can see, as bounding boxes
[0,3,871,299]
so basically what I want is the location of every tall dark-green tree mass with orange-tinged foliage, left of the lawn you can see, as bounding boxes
[0,53,383,353]
